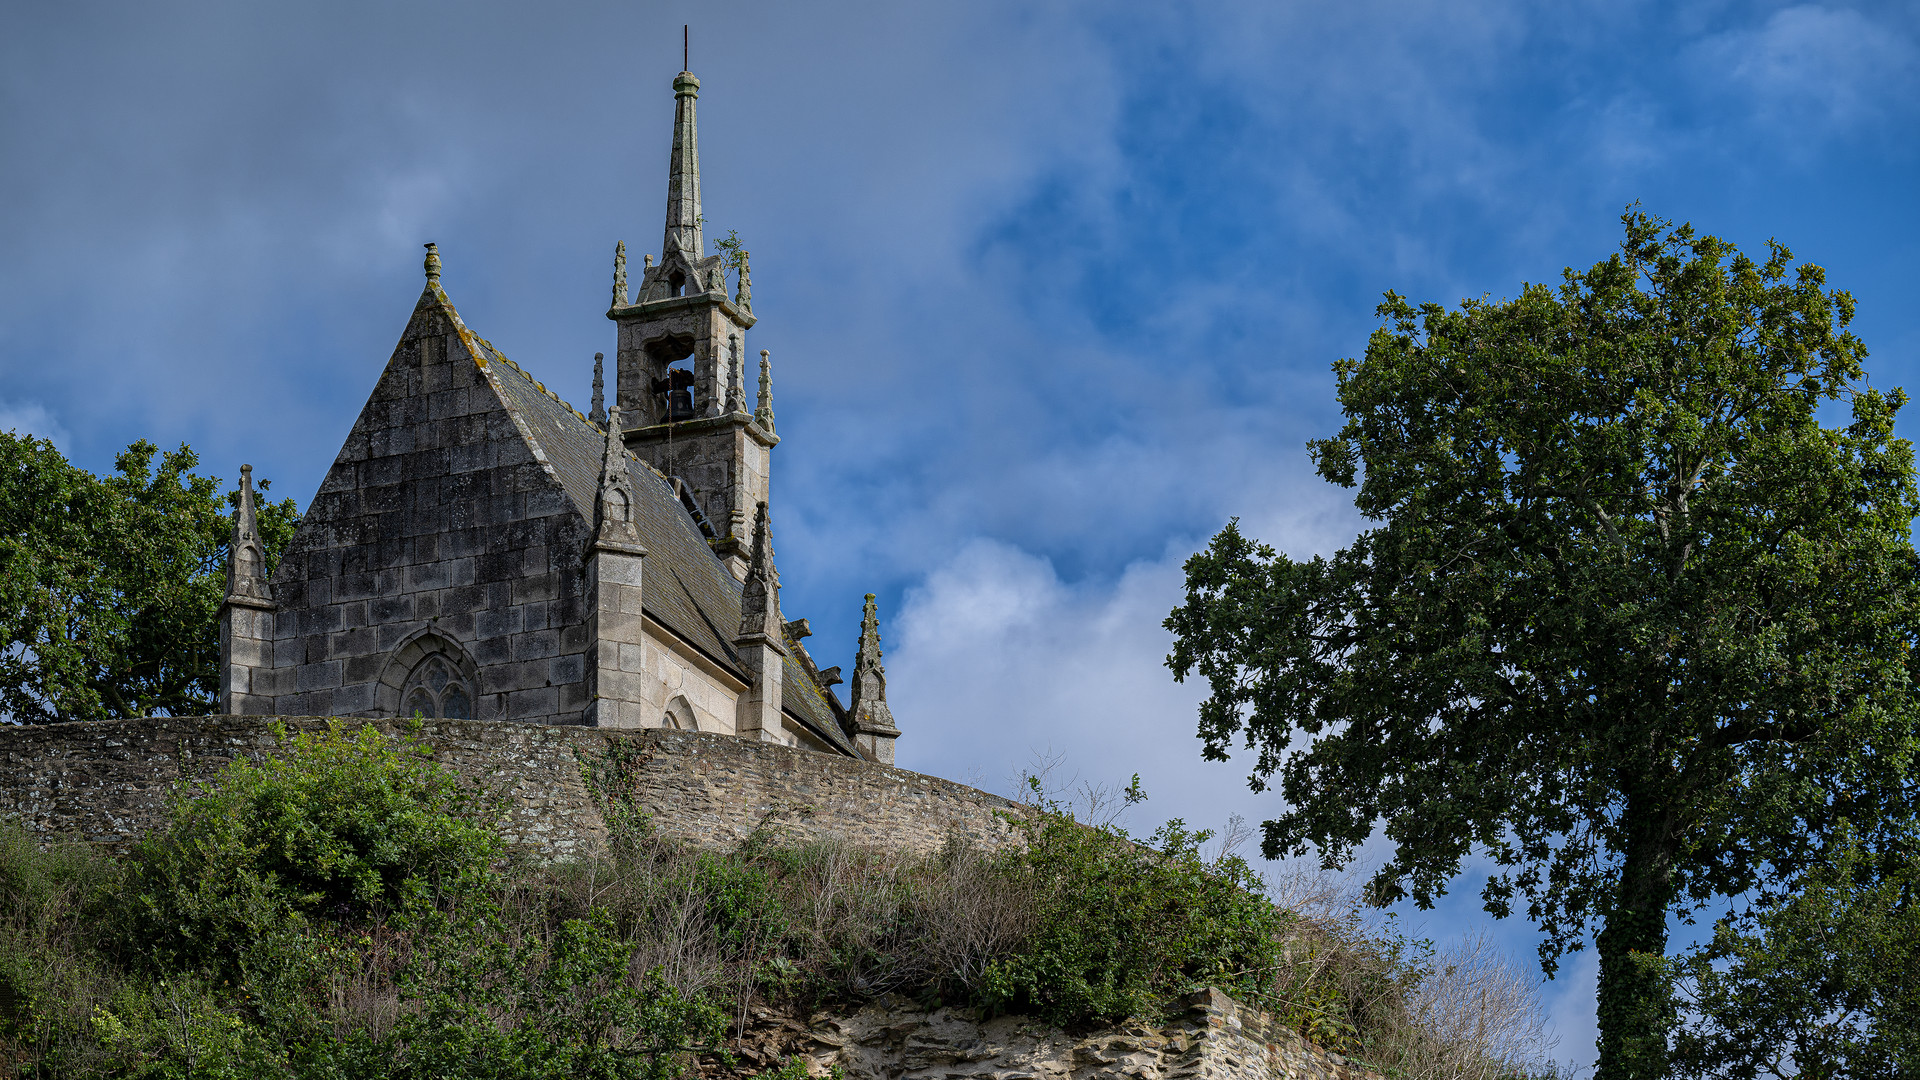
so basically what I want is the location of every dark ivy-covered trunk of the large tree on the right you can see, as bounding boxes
[1594,794,1674,1080]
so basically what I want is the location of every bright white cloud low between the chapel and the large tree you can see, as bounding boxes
[887,540,1236,810]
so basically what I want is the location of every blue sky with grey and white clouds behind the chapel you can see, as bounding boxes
[0,0,1920,1061]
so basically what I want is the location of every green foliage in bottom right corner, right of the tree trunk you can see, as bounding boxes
[1674,826,1920,1080]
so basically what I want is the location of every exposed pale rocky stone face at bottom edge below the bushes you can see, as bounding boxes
[795,990,1380,1080]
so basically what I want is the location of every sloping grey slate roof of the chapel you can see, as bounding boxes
[476,336,860,757]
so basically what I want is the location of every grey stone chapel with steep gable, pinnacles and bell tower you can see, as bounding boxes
[221,71,900,765]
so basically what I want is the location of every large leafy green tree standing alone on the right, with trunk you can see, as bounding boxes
[1167,208,1920,1080]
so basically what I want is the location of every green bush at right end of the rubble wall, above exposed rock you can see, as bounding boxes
[979,776,1290,1024]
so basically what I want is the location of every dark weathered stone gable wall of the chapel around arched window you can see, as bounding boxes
[253,284,588,724]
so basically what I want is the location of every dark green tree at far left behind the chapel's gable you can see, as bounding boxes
[0,432,298,723]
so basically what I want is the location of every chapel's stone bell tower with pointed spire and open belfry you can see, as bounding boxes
[607,71,780,580]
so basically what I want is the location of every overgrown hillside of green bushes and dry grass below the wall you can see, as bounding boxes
[0,726,1540,1080]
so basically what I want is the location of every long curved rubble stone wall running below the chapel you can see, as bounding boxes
[0,717,1016,859]
